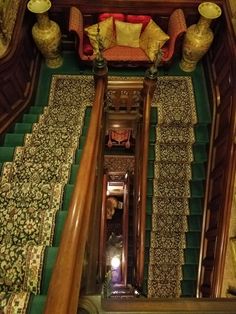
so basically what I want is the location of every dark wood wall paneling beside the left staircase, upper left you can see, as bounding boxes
[0,1,39,134]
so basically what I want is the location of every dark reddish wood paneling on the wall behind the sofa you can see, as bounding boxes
[50,0,201,37]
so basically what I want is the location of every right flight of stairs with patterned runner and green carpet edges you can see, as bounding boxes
[143,77,210,298]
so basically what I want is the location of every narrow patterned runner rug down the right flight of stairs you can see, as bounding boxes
[148,77,197,298]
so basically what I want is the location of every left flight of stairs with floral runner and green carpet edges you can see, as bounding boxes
[0,76,94,313]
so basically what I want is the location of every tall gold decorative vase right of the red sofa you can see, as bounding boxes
[180,2,221,72]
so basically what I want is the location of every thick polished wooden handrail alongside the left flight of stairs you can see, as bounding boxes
[45,73,106,314]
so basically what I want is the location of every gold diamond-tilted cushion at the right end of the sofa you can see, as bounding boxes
[139,20,170,61]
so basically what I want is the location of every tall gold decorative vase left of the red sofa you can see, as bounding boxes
[27,0,63,68]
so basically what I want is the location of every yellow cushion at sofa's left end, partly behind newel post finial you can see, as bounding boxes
[84,17,115,53]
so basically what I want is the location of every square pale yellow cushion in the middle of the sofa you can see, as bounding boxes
[115,20,143,47]
